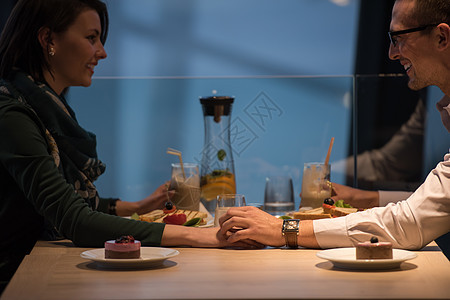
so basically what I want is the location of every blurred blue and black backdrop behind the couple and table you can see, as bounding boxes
[0,0,449,206]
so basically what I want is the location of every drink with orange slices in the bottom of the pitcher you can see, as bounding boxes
[200,170,236,212]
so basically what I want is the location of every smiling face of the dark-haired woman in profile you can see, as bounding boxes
[46,10,106,94]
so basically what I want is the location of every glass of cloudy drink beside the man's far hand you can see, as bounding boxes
[300,163,331,210]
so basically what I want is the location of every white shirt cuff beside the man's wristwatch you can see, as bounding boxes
[313,217,353,249]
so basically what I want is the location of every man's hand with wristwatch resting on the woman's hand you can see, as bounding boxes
[219,206,285,247]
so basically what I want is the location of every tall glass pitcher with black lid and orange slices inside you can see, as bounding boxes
[200,96,236,215]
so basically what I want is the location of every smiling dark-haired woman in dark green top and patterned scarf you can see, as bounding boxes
[0,0,253,290]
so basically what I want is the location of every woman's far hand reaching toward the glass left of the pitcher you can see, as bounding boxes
[116,182,175,217]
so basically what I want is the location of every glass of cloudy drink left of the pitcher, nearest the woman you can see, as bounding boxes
[170,163,200,210]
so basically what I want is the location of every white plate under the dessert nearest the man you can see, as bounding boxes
[316,248,417,270]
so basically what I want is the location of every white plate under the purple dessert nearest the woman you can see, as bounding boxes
[80,247,180,268]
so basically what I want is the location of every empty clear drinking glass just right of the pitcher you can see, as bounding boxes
[264,176,295,217]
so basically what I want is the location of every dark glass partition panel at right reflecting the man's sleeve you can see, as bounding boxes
[347,74,448,191]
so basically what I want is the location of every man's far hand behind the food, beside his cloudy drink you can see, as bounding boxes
[331,183,380,209]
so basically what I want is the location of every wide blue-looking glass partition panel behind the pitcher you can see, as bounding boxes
[68,76,353,207]
